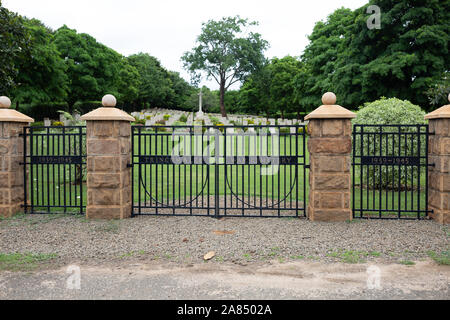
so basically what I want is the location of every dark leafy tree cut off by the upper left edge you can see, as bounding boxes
[0,1,30,94]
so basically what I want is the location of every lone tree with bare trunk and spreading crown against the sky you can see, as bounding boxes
[181,16,268,117]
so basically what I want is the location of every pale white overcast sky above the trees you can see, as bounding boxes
[2,0,368,89]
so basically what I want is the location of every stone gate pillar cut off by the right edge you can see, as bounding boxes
[425,94,450,224]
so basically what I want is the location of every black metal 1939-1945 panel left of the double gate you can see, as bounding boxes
[23,126,86,214]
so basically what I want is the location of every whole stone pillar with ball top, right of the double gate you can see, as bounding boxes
[305,92,356,221]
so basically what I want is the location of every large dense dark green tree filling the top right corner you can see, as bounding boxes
[330,0,450,109]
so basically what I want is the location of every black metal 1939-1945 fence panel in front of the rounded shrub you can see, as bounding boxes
[352,125,430,219]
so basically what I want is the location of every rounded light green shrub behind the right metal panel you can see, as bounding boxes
[352,97,426,188]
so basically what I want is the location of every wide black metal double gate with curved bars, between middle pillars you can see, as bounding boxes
[132,125,307,217]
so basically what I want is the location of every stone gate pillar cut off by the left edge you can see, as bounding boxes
[0,96,34,217]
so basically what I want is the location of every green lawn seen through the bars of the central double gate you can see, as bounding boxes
[133,134,309,202]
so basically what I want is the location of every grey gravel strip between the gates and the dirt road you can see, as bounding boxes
[0,211,450,265]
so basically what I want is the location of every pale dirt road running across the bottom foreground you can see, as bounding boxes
[0,260,450,300]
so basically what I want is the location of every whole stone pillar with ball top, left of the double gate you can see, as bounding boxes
[81,95,134,219]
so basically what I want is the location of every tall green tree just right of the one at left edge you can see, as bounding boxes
[12,18,68,108]
